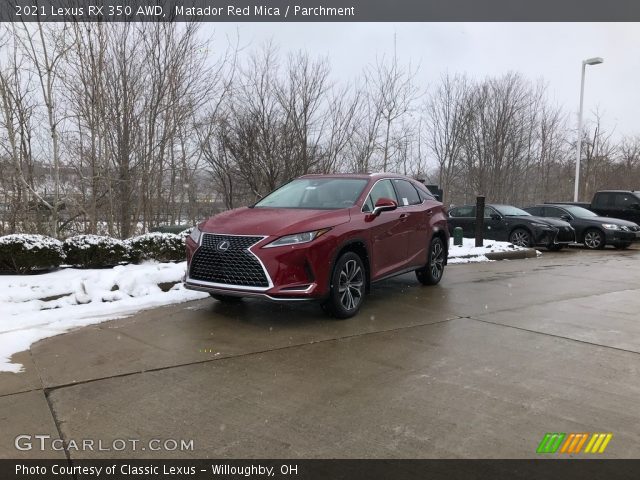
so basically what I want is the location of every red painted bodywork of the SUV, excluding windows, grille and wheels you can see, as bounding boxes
[185,174,449,300]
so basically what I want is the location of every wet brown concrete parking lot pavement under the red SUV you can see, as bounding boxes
[0,246,640,458]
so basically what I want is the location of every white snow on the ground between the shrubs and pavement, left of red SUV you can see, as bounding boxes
[0,262,207,372]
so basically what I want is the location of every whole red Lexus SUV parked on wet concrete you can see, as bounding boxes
[184,174,449,318]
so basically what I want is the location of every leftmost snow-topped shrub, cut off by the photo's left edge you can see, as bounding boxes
[0,234,65,273]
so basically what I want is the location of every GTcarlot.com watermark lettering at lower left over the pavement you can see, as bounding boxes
[13,434,194,452]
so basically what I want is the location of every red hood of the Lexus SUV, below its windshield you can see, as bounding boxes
[199,207,351,237]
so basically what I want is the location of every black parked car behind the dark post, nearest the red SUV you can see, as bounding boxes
[449,204,575,250]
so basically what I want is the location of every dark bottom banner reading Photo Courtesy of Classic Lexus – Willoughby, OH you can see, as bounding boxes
[5,459,640,480]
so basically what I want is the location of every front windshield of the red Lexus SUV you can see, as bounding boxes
[255,178,368,210]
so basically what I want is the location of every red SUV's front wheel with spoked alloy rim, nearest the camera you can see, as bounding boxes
[323,252,366,319]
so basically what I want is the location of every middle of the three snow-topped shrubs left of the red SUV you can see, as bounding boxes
[63,235,130,268]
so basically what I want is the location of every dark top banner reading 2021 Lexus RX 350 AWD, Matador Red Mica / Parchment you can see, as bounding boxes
[0,0,640,22]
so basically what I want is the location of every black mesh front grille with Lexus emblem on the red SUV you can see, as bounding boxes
[189,233,269,287]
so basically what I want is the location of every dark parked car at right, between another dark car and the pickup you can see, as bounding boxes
[525,204,640,249]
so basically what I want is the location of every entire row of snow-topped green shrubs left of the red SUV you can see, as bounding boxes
[0,229,190,274]
